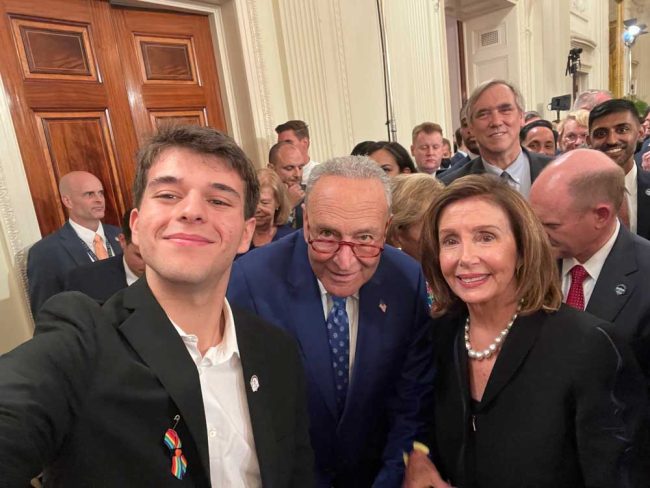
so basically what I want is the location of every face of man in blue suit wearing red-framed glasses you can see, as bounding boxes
[304,176,388,297]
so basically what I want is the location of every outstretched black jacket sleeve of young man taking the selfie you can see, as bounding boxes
[0,294,98,486]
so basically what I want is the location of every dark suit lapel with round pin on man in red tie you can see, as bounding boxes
[586,229,638,323]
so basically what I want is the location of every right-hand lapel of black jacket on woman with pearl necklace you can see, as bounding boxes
[481,312,545,409]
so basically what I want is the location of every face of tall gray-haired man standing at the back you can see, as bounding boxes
[469,85,523,165]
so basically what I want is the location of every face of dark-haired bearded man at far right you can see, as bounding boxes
[589,111,643,173]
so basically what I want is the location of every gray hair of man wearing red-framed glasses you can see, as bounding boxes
[305,156,392,210]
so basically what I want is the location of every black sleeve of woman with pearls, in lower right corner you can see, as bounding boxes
[574,327,647,487]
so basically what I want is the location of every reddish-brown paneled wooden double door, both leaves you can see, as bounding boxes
[0,0,225,235]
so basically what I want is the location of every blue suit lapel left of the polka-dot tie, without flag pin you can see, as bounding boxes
[285,236,338,418]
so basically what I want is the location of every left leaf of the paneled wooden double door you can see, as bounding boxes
[0,0,137,235]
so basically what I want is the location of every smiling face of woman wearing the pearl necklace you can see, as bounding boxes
[438,197,518,308]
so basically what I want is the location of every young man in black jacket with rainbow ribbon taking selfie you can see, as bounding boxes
[0,127,313,488]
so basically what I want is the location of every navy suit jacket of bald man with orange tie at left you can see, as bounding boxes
[27,222,122,317]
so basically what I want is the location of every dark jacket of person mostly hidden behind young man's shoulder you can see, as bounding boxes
[64,255,127,303]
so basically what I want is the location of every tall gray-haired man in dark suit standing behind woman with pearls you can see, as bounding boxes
[440,80,551,197]
